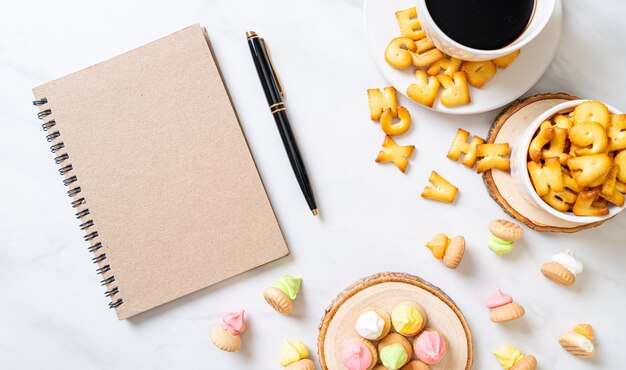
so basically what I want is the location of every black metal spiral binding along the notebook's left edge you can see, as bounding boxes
[33,98,124,308]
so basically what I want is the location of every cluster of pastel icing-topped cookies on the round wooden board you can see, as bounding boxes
[341,301,448,370]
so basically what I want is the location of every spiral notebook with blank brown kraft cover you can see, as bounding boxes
[33,25,288,319]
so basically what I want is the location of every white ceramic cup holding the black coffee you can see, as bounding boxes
[417,0,556,61]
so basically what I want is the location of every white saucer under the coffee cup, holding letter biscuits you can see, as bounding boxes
[364,0,563,114]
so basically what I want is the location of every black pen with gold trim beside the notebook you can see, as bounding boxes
[246,31,319,216]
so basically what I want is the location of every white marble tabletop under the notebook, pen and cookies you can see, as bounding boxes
[0,0,626,370]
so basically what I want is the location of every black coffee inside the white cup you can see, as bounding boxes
[426,0,535,50]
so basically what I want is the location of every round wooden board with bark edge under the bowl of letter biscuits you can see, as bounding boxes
[483,93,606,233]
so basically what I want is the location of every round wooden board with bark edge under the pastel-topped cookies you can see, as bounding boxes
[317,272,473,370]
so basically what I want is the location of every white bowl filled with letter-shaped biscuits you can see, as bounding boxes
[511,100,624,224]
